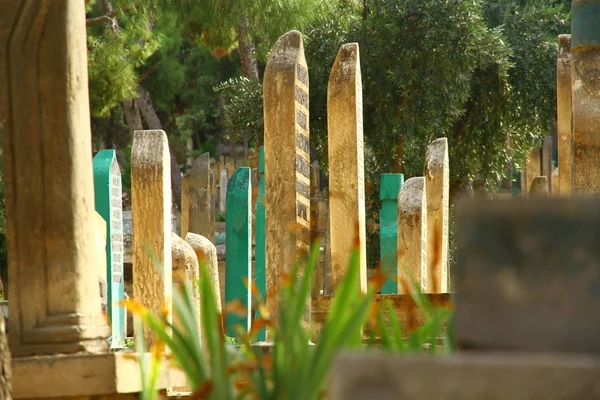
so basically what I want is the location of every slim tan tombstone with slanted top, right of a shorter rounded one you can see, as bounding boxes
[425,138,450,293]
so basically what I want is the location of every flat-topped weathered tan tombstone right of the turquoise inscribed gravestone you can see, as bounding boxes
[131,130,173,346]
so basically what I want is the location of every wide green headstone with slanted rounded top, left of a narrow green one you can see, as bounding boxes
[225,167,252,337]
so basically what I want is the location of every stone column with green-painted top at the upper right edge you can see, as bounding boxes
[571,0,600,194]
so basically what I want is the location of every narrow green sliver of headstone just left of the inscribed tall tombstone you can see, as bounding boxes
[254,146,267,341]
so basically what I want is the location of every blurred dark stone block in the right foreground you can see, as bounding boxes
[455,197,600,355]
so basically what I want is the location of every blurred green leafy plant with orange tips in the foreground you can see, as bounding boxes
[127,239,452,400]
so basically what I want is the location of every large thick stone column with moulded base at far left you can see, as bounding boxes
[0,0,110,357]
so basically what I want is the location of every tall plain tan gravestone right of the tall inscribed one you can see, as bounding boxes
[327,43,367,292]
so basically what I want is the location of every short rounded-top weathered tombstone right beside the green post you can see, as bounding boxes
[398,177,429,294]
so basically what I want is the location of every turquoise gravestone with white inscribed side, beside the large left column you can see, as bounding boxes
[93,150,125,348]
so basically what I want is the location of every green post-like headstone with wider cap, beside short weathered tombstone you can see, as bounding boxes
[379,174,404,294]
